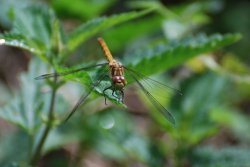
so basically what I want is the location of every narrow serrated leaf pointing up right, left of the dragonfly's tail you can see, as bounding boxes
[67,10,152,51]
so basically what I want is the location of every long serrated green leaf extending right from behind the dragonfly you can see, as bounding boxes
[124,34,241,75]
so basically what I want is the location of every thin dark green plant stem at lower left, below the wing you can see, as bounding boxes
[30,77,57,166]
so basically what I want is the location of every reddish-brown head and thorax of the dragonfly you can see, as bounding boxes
[109,60,126,89]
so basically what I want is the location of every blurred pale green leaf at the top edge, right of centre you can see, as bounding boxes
[129,1,215,40]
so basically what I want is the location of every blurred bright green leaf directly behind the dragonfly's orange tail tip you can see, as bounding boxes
[102,15,162,52]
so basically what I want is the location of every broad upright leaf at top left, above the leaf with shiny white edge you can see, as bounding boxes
[11,5,55,50]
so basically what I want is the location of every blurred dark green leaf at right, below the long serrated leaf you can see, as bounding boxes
[172,73,228,142]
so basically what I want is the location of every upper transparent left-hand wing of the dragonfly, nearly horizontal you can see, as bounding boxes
[35,63,108,80]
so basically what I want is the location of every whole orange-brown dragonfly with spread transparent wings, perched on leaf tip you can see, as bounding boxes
[35,37,181,124]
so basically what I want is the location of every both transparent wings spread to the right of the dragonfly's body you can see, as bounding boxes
[124,67,178,124]
